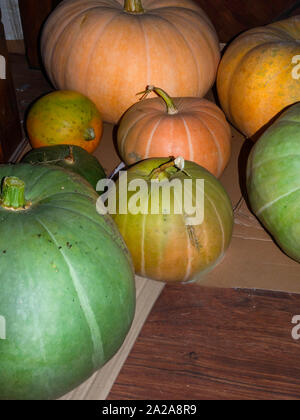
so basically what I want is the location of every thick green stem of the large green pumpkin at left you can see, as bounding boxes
[0,176,27,210]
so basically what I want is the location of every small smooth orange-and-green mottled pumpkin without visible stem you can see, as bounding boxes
[26,91,103,153]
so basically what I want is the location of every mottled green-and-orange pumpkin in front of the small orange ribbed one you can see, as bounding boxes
[102,157,233,283]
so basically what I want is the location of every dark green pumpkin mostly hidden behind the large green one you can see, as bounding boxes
[22,144,106,190]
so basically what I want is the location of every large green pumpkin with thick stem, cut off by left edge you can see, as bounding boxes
[0,164,135,400]
